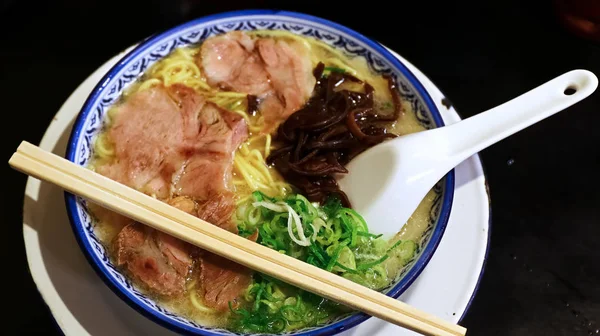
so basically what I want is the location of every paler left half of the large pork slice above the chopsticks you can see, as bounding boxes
[97,87,185,198]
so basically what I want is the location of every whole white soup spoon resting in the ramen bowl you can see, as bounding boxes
[338,70,598,236]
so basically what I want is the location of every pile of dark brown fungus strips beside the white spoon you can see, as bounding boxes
[268,63,402,207]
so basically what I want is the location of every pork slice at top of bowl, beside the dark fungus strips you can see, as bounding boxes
[198,31,315,132]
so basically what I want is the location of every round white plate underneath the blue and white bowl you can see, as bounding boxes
[23,47,490,336]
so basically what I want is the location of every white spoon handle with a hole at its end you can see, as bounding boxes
[440,70,598,166]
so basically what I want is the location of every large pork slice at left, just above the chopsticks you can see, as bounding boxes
[97,84,248,210]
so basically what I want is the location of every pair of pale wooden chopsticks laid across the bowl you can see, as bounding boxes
[9,141,466,335]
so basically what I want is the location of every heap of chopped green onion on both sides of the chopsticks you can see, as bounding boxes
[230,191,410,334]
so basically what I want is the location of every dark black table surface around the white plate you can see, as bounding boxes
[0,0,600,335]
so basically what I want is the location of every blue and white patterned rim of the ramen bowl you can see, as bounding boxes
[65,10,454,336]
